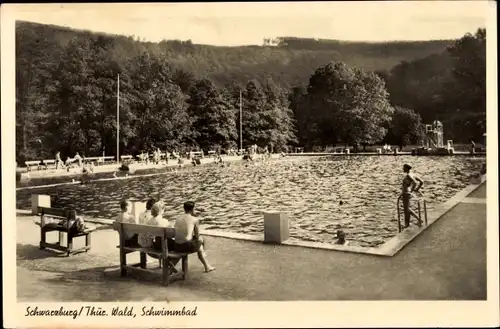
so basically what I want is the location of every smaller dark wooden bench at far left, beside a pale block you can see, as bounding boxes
[38,207,95,256]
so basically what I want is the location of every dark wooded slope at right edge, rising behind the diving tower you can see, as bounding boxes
[379,29,486,142]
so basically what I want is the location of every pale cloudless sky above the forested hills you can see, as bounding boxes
[8,1,493,46]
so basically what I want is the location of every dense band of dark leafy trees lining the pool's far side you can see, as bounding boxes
[16,23,485,161]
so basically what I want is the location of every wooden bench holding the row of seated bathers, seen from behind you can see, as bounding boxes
[113,221,188,286]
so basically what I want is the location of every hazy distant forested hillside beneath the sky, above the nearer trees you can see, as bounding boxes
[16,22,453,88]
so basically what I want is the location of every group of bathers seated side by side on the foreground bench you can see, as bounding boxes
[115,199,215,272]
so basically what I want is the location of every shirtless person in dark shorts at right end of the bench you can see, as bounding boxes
[174,201,215,272]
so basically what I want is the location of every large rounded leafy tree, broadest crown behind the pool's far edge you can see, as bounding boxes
[307,62,393,145]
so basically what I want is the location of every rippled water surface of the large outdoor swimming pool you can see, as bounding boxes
[17,156,485,247]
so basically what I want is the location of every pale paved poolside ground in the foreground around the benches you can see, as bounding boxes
[17,184,486,301]
